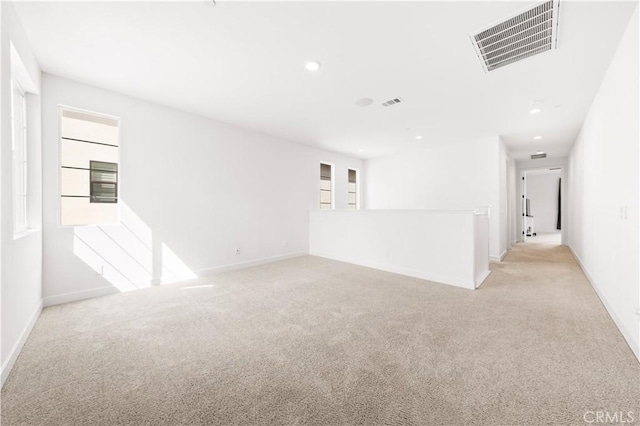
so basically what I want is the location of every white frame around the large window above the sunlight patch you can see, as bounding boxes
[56,104,122,228]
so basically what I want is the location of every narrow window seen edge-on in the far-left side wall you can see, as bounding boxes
[11,79,28,233]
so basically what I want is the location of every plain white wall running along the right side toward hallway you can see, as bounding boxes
[567,7,640,359]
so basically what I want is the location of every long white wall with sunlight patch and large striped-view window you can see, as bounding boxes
[42,74,362,304]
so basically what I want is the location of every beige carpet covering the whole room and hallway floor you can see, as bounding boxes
[2,245,640,426]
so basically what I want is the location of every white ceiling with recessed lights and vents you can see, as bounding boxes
[15,0,636,159]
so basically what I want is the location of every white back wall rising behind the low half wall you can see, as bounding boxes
[364,136,506,259]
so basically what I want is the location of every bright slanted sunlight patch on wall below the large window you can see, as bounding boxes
[73,201,197,292]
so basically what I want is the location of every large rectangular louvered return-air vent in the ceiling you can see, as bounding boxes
[470,0,560,72]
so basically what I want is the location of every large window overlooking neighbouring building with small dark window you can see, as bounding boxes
[60,108,119,225]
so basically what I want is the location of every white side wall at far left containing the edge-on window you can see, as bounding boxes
[0,2,42,383]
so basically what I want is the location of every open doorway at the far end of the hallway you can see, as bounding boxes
[522,167,563,245]
